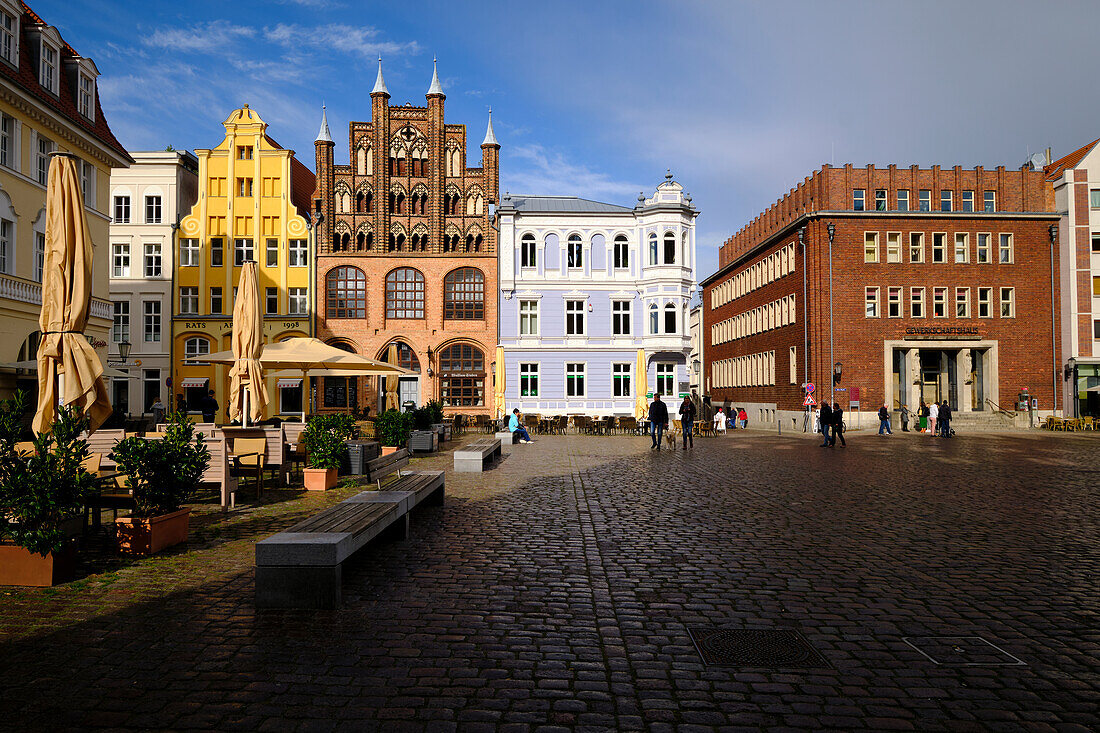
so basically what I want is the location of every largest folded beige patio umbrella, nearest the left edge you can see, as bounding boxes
[32,154,111,433]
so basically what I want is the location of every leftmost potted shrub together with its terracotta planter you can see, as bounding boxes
[0,392,96,586]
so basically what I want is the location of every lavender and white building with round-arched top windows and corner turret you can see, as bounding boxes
[496,174,699,415]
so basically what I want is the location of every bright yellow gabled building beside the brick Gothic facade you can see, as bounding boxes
[172,105,314,422]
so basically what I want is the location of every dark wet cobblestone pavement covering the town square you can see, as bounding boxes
[0,434,1100,733]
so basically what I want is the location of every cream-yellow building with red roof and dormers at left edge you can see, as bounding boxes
[0,0,132,397]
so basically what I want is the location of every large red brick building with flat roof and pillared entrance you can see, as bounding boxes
[702,165,1062,425]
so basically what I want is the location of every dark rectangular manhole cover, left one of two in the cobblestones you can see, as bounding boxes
[688,628,829,669]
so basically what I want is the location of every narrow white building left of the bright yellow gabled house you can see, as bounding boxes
[108,151,198,416]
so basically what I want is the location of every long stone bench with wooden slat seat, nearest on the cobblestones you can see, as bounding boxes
[256,464,443,609]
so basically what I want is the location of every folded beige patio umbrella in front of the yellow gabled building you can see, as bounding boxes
[229,262,268,425]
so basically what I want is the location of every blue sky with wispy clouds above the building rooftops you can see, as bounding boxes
[38,0,1100,278]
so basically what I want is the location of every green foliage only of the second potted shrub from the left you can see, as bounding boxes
[112,412,210,517]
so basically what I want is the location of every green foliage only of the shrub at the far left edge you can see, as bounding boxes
[0,392,96,556]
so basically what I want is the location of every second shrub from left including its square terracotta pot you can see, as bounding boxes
[112,412,210,555]
